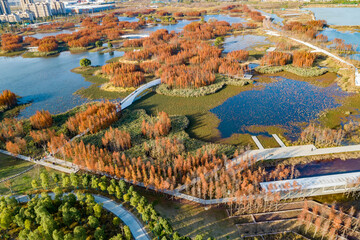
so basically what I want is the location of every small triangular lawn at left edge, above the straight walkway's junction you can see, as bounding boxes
[0,153,33,179]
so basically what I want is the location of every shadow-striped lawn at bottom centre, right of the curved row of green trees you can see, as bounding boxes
[137,188,241,240]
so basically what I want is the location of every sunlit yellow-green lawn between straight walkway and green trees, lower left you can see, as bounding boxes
[0,165,61,195]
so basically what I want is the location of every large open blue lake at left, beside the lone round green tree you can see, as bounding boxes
[0,52,123,117]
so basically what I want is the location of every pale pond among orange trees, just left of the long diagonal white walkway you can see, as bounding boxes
[223,34,269,53]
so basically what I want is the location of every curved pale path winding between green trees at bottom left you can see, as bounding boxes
[10,193,150,240]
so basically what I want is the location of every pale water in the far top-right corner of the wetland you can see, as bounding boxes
[305,7,360,26]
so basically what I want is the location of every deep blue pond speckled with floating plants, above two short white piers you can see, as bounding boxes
[210,77,345,138]
